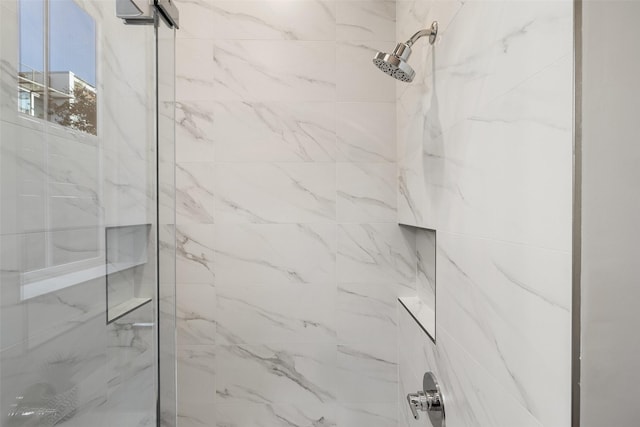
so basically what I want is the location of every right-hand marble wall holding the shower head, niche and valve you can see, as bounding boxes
[396,0,573,427]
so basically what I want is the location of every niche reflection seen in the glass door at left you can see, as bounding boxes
[105,224,155,323]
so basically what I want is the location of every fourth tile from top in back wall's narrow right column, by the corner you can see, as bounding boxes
[337,163,396,222]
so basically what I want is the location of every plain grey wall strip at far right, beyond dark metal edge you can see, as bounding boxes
[580,1,640,427]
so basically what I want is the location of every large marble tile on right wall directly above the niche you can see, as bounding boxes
[399,53,572,251]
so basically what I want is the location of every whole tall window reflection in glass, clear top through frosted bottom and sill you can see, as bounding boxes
[16,0,105,298]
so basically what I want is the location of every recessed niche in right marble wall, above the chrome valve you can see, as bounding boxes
[398,225,436,342]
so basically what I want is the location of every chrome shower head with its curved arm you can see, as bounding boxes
[373,21,438,83]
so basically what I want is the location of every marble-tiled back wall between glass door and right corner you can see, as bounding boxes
[172,0,416,427]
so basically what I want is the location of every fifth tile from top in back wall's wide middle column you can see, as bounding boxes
[214,224,336,285]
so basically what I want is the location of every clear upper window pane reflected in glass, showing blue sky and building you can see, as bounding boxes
[18,0,98,135]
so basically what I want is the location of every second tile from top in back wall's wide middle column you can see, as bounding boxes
[208,40,340,101]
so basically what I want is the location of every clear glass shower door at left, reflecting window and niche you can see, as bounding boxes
[0,0,176,427]
